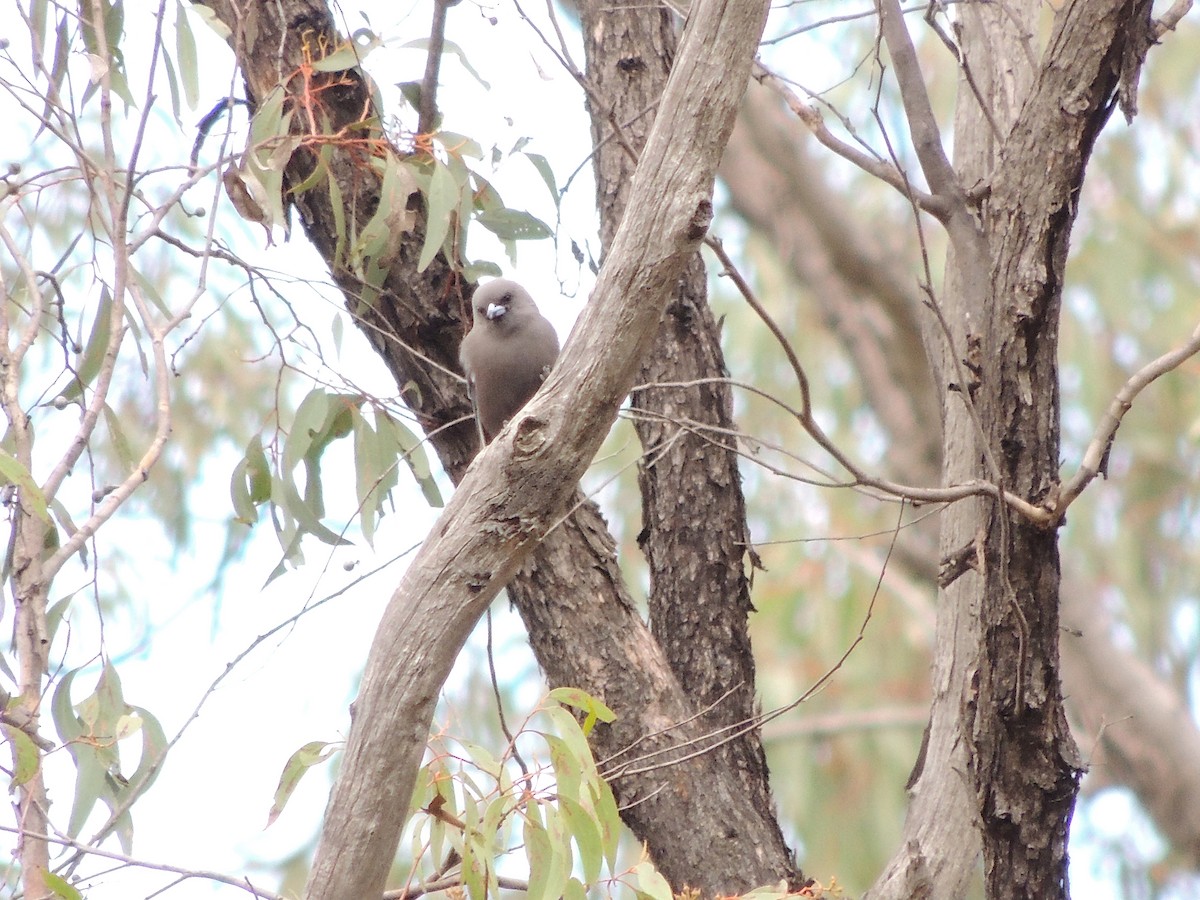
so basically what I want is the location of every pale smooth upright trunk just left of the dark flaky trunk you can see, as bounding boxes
[872,4,1032,898]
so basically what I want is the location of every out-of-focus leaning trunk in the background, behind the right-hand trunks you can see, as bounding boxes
[720,10,1200,895]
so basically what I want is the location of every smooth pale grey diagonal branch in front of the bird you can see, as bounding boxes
[298,0,767,898]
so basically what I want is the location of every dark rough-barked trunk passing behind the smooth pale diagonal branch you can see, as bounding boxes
[580,0,798,883]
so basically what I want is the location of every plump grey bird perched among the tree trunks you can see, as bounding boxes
[458,278,558,444]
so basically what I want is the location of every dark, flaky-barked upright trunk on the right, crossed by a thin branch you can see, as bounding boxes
[881,1,1148,898]
